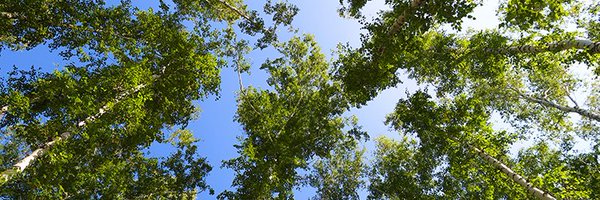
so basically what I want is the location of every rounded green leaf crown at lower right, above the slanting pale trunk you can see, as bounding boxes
[380,91,527,199]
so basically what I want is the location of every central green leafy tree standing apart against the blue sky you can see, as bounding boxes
[219,36,362,199]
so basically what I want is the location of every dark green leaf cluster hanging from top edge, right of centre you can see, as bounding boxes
[336,0,480,105]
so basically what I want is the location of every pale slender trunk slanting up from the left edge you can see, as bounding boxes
[0,82,150,185]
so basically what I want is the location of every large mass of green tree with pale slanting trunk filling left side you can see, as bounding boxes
[0,1,251,199]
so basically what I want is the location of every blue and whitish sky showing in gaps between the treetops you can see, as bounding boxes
[0,0,510,199]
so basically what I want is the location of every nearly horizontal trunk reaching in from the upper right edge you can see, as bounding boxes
[487,39,600,54]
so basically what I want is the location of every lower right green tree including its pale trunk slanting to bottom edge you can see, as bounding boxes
[387,92,554,199]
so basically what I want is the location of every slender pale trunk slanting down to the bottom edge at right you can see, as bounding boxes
[450,136,556,200]
